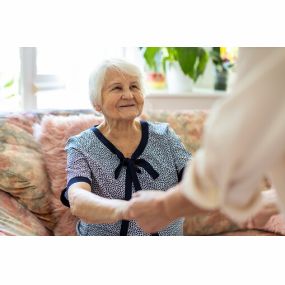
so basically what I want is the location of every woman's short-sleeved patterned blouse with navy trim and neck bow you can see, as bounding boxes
[61,121,191,236]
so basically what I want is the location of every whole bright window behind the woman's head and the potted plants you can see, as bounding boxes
[0,46,237,112]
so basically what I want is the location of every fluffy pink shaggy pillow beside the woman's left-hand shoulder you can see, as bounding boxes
[35,115,102,235]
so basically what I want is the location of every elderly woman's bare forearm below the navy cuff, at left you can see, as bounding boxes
[68,188,128,224]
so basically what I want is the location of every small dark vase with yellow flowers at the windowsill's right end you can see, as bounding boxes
[207,47,237,91]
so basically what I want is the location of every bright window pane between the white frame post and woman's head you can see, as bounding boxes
[36,47,143,109]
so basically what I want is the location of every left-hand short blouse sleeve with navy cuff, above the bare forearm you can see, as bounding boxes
[61,138,91,207]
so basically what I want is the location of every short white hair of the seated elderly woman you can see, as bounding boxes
[89,59,144,106]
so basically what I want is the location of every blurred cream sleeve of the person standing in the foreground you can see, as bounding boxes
[182,48,285,221]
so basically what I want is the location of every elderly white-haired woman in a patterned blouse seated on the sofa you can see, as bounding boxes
[61,60,191,235]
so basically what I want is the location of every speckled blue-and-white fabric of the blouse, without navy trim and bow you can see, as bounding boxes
[66,122,191,236]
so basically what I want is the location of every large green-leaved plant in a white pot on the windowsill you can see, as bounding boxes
[142,47,209,92]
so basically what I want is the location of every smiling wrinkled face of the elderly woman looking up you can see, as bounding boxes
[96,69,144,120]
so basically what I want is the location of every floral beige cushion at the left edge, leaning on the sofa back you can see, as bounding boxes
[0,120,56,229]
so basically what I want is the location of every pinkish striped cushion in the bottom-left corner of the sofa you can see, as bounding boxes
[0,191,51,236]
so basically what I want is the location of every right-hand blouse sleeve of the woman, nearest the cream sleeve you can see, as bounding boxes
[167,126,191,181]
